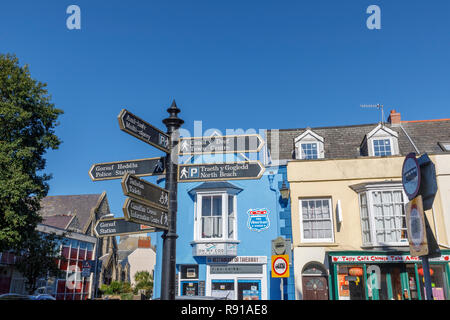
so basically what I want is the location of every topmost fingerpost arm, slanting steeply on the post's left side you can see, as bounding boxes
[117,109,170,153]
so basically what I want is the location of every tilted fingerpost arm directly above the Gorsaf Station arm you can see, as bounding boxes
[123,198,169,230]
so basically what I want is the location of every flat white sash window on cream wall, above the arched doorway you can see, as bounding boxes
[299,198,334,242]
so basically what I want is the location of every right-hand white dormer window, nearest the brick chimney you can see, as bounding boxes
[360,124,399,157]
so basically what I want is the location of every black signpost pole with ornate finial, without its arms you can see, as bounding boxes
[161,100,184,300]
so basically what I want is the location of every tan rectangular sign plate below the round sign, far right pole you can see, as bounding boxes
[406,196,428,257]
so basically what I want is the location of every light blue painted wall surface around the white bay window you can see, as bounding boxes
[154,162,285,300]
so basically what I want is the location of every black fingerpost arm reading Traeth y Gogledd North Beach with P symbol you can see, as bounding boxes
[178,161,265,182]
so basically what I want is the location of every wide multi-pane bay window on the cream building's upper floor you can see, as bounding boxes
[359,188,408,246]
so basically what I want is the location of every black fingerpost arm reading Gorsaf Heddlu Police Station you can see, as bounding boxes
[89,158,164,181]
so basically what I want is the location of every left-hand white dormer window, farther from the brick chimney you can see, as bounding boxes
[294,129,324,160]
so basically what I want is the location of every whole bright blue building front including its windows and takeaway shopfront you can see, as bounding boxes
[153,146,295,300]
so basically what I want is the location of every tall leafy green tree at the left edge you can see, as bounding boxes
[0,54,63,252]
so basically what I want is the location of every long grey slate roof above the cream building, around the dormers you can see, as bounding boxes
[267,119,450,161]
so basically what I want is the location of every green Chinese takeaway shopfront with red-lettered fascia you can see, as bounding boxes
[328,250,450,300]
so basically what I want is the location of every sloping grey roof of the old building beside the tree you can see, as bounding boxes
[39,194,102,230]
